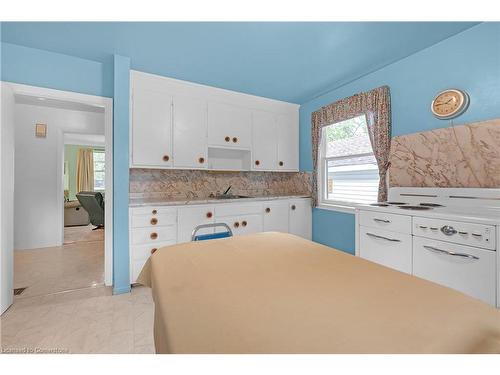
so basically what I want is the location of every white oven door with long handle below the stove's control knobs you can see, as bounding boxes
[413,237,496,305]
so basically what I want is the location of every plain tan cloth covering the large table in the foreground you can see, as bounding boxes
[139,233,500,353]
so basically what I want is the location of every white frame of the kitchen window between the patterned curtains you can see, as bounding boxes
[317,114,374,214]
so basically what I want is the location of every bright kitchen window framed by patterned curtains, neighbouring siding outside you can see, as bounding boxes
[318,115,379,205]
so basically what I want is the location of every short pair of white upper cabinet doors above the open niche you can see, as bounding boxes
[208,102,252,149]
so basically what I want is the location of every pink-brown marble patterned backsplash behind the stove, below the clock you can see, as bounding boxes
[389,119,500,188]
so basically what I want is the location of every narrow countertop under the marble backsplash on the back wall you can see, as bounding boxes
[129,194,310,207]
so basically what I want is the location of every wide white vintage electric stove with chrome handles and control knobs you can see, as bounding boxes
[356,188,500,307]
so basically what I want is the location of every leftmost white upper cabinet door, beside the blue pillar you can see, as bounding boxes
[132,89,172,167]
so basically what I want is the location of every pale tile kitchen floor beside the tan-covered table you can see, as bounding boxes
[0,287,154,353]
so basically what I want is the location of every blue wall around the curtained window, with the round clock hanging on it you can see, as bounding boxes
[300,23,500,252]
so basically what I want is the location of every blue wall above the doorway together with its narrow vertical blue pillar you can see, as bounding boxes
[1,43,130,294]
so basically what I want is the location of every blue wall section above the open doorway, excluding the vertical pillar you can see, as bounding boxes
[1,43,113,97]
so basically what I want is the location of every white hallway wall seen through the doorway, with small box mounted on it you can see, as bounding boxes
[14,104,104,250]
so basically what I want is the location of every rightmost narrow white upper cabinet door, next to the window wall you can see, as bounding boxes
[276,114,299,171]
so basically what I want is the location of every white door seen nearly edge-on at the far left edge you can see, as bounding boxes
[0,82,14,314]
